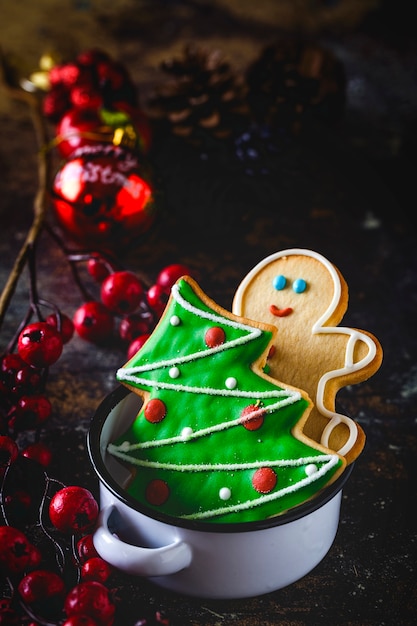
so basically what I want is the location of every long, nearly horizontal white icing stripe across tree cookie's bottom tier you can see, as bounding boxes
[108,444,338,472]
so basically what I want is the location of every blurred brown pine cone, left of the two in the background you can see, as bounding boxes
[148,45,249,139]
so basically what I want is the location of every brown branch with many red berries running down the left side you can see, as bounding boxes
[0,46,189,626]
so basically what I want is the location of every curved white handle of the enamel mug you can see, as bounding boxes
[93,504,192,576]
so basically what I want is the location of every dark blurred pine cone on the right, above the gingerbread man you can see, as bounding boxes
[247,40,346,134]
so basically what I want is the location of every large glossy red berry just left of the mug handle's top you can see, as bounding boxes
[49,486,98,533]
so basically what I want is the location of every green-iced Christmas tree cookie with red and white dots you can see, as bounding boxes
[109,277,345,523]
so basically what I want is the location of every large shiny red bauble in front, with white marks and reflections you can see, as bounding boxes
[52,144,156,250]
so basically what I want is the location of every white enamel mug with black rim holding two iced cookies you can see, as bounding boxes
[87,387,352,599]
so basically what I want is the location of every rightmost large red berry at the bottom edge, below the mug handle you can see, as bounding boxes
[64,580,116,626]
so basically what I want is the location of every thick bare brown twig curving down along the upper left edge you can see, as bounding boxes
[0,49,51,328]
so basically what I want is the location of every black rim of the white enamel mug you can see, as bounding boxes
[87,385,354,533]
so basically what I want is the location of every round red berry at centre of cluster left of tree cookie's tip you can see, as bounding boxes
[101,271,143,315]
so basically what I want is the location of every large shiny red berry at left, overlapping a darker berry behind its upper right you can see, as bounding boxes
[18,322,62,367]
